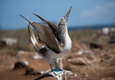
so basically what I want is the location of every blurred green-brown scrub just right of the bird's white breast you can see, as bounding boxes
[69,29,96,47]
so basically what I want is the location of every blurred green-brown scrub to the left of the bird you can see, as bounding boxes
[0,29,34,55]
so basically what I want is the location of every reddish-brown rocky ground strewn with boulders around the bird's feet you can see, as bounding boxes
[0,40,115,80]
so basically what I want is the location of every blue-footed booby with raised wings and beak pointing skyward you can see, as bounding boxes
[20,6,72,75]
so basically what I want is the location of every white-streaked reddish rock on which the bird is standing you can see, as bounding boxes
[35,70,91,80]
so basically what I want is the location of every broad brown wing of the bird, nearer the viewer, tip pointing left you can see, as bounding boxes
[20,15,60,54]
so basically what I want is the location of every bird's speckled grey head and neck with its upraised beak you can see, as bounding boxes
[57,6,72,47]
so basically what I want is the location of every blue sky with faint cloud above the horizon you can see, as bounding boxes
[0,0,115,29]
